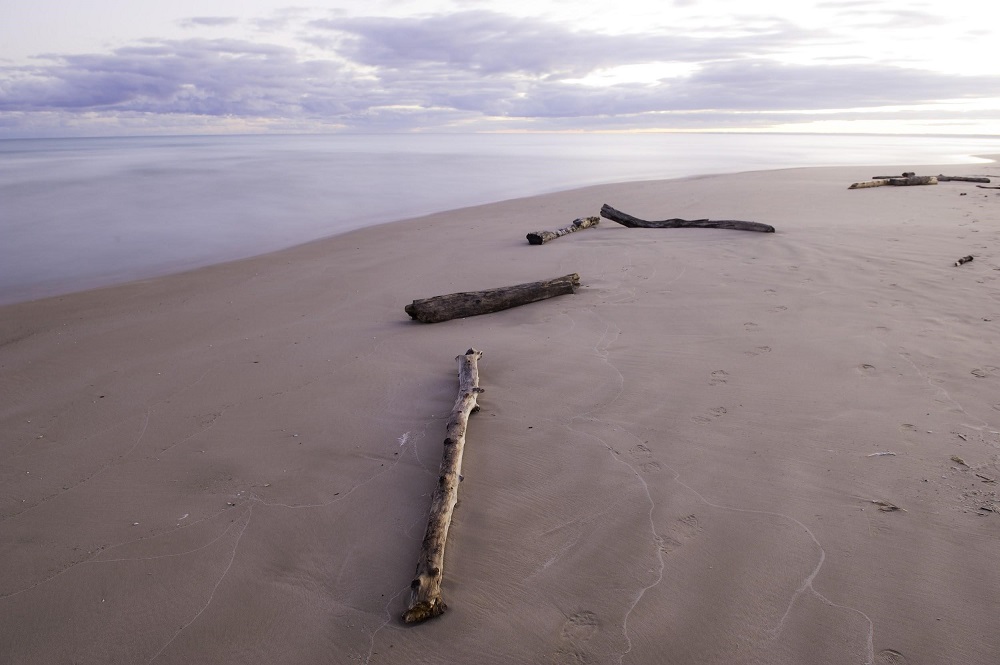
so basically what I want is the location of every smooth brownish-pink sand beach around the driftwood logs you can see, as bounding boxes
[0,164,1000,665]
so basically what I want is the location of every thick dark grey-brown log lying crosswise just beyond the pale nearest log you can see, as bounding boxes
[404,273,580,323]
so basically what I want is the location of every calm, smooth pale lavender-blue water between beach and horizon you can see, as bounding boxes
[0,134,1000,303]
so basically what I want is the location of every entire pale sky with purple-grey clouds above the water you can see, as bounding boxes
[0,0,1000,138]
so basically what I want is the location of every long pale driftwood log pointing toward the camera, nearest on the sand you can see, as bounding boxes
[403,349,483,623]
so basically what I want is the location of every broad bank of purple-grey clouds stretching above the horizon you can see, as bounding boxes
[0,11,1000,135]
